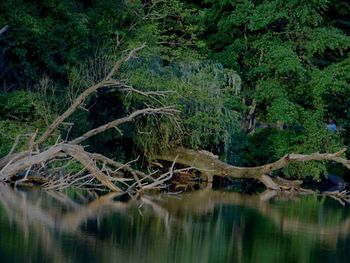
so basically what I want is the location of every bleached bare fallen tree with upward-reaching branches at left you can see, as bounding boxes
[0,44,177,194]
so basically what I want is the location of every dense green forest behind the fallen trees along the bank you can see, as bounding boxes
[0,0,350,193]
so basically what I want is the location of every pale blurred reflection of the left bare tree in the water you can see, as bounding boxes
[0,184,137,262]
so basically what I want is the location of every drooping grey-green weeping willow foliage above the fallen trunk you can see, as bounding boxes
[119,57,242,163]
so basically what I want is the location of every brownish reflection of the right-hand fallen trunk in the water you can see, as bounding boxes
[160,189,350,243]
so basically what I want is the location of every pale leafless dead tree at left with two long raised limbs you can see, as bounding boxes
[0,44,177,191]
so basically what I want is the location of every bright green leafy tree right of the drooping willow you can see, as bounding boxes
[194,0,350,178]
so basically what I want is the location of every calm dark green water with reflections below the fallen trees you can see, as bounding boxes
[0,185,350,262]
